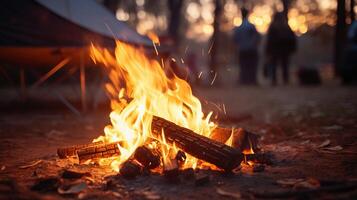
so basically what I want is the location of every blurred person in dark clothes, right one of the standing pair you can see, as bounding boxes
[265,12,297,85]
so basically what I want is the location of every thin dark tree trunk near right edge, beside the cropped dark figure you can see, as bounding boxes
[334,0,346,75]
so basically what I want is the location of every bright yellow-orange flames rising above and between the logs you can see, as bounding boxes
[91,41,216,171]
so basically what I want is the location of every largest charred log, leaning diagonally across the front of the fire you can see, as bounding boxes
[151,116,243,171]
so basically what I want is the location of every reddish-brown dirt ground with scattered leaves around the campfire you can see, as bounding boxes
[0,86,357,199]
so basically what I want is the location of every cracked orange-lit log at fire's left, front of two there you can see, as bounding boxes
[77,142,120,163]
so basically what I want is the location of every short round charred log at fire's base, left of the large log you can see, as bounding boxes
[134,146,160,169]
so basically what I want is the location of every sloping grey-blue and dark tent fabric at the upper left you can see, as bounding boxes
[0,0,152,47]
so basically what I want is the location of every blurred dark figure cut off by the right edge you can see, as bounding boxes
[341,20,357,85]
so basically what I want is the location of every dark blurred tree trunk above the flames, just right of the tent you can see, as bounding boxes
[167,0,183,47]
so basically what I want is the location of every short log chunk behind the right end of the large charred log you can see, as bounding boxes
[211,127,259,153]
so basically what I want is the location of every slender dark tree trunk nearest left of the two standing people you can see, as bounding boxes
[208,0,223,83]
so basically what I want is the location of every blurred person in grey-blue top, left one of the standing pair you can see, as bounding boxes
[233,8,260,85]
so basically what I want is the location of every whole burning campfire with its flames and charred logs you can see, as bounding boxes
[58,41,259,177]
